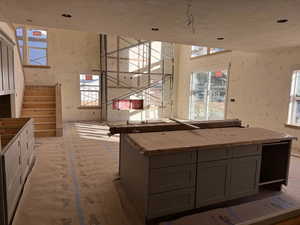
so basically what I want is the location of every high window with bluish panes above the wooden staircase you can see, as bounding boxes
[16,27,48,66]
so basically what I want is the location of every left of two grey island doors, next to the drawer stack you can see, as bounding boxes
[197,160,230,208]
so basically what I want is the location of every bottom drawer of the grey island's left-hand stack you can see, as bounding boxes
[147,189,195,218]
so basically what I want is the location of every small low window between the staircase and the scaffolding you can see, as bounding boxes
[80,74,100,107]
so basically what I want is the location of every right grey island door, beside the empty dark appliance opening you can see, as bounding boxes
[229,156,261,199]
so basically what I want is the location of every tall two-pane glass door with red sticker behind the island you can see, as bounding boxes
[189,71,227,120]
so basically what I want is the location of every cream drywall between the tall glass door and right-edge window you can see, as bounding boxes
[227,47,300,148]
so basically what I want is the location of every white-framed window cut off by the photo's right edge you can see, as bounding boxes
[288,70,300,126]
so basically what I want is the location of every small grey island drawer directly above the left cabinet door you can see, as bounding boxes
[198,148,229,162]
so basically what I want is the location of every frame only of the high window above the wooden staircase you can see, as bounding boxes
[15,25,50,68]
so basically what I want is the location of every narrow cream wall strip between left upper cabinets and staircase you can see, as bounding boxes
[0,22,24,118]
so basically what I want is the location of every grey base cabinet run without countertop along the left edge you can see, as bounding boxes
[0,118,34,225]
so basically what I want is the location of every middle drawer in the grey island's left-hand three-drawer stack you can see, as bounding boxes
[150,164,196,194]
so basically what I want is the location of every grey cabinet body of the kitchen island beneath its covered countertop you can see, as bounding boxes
[120,139,287,221]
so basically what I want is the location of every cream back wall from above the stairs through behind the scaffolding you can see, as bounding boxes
[24,28,173,121]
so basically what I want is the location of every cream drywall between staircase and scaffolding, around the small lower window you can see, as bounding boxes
[24,26,100,121]
